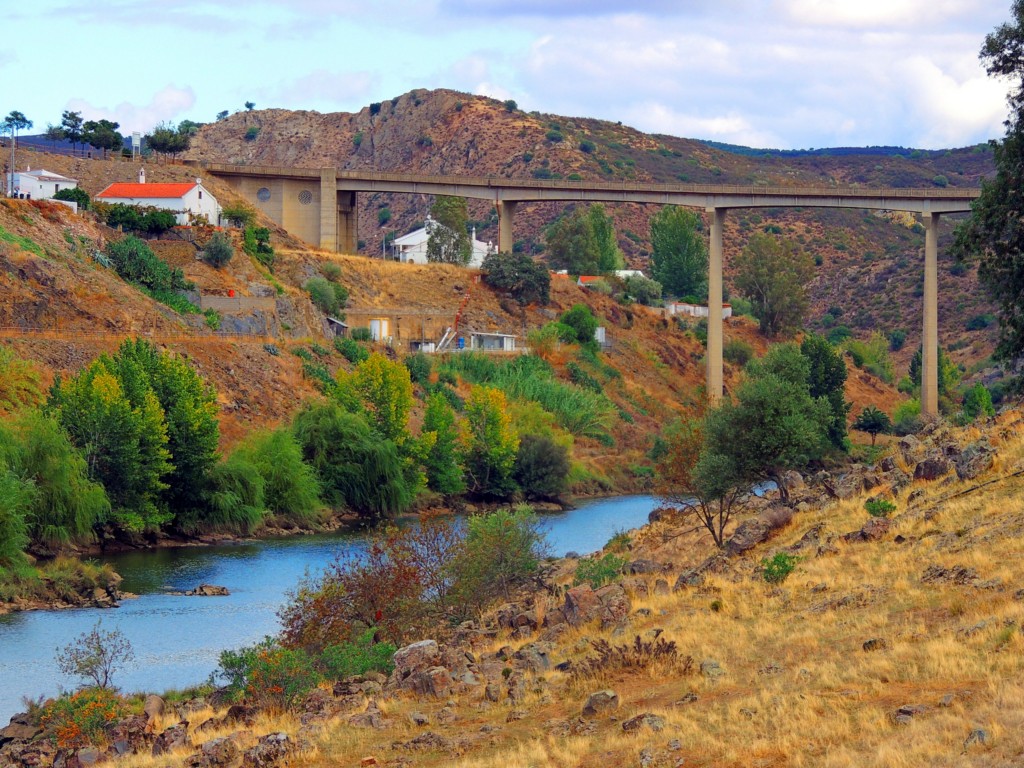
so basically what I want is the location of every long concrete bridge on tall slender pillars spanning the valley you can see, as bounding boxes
[203,158,980,416]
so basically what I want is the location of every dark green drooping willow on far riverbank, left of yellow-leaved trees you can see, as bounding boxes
[294,402,412,518]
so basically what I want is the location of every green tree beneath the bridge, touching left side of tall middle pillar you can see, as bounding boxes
[650,206,708,300]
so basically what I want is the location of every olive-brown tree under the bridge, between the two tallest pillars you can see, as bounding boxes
[733,232,814,336]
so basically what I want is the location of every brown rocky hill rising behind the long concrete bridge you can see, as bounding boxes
[180,90,995,382]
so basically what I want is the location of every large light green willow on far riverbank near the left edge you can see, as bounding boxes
[0,410,111,546]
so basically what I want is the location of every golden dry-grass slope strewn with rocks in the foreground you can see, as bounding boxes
[0,411,1024,768]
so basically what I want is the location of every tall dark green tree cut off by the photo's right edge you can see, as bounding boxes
[940,0,1024,366]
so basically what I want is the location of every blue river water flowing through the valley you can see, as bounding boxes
[0,496,657,726]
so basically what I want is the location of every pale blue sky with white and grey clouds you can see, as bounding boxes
[0,0,1011,150]
